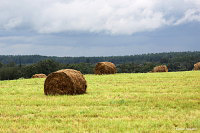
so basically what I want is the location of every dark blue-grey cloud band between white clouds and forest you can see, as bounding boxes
[0,23,200,56]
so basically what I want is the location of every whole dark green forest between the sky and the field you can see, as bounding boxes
[0,51,200,80]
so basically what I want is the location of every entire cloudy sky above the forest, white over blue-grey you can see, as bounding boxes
[0,0,200,56]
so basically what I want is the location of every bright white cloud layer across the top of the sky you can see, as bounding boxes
[0,0,200,34]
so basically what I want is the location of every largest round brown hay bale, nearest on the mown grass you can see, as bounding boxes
[44,69,87,95]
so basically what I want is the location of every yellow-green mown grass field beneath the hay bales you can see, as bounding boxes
[0,71,200,133]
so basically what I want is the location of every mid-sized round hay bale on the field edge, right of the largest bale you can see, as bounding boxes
[94,62,117,75]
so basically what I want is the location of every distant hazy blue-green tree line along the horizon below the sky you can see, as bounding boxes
[0,51,200,64]
